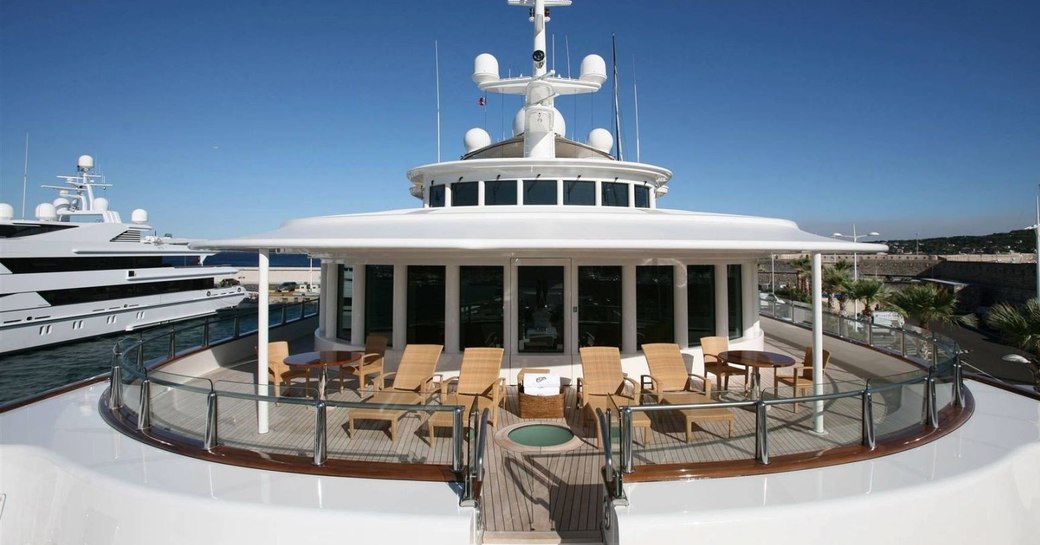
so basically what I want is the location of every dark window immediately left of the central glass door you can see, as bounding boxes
[459,266,504,348]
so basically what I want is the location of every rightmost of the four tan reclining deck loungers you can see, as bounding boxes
[641,342,736,443]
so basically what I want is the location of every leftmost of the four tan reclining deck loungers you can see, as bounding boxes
[347,344,444,441]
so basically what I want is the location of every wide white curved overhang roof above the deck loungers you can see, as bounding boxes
[191,206,888,256]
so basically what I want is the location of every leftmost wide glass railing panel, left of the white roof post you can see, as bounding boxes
[148,370,212,441]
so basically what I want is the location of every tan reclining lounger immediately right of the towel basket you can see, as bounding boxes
[577,346,650,445]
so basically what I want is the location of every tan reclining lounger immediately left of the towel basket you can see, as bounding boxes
[426,347,505,444]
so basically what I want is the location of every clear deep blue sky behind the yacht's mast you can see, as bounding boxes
[0,0,1040,238]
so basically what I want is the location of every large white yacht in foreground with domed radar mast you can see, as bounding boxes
[0,0,1040,545]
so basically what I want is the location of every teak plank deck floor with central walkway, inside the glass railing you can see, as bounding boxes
[138,364,902,543]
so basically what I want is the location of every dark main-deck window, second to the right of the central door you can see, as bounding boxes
[635,265,675,348]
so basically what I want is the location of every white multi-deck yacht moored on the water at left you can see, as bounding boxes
[0,155,245,354]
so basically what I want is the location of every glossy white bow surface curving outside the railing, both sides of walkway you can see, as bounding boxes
[0,383,1040,545]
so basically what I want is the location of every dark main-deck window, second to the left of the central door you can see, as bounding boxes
[405,265,444,344]
